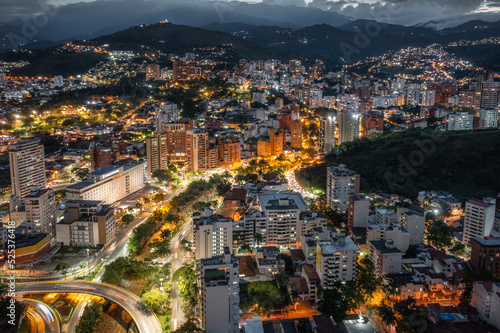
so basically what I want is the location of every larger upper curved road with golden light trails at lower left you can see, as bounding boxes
[16,281,162,333]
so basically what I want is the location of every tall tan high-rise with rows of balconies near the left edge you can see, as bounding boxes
[8,139,47,199]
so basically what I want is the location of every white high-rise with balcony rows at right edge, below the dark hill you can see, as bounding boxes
[462,198,496,244]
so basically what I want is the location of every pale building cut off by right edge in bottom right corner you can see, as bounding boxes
[472,281,500,329]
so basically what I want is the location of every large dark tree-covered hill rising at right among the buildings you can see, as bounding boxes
[296,129,500,201]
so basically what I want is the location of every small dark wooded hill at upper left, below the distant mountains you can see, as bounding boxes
[12,52,106,77]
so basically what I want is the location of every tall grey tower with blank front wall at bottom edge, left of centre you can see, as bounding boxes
[197,248,240,333]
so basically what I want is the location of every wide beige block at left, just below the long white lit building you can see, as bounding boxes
[56,200,116,246]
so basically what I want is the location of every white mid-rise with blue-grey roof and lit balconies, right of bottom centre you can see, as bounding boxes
[316,233,359,288]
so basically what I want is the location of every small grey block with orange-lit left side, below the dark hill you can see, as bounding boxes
[366,239,403,276]
